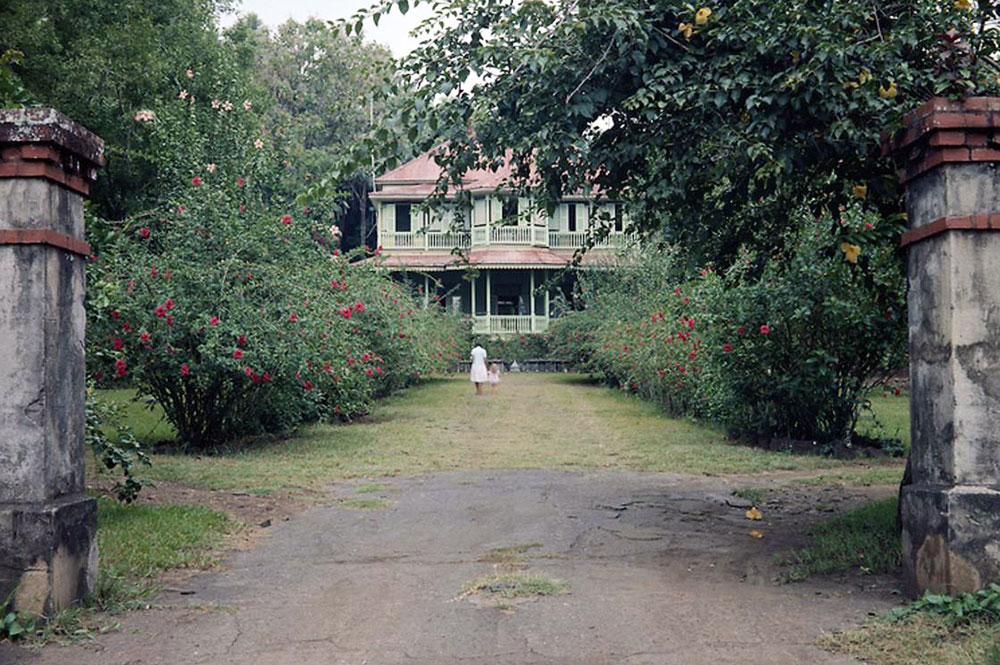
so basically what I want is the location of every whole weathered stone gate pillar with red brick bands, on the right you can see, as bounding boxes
[889,98,1000,596]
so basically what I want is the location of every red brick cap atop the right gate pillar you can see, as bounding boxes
[882,97,1000,184]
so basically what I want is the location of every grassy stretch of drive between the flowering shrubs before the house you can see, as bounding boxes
[95,374,902,491]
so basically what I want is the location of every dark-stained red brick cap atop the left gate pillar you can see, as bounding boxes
[0,108,104,196]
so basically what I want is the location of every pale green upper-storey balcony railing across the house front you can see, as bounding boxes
[379,226,626,251]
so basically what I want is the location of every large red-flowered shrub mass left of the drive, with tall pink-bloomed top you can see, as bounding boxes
[88,72,465,448]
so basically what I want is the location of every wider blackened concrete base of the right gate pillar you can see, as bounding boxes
[901,485,1000,596]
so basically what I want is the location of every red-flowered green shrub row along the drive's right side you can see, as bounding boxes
[550,202,906,442]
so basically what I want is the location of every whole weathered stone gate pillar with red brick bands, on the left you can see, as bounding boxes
[0,108,104,615]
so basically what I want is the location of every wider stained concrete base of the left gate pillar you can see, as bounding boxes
[0,497,97,616]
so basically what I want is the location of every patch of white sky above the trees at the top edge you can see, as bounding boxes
[221,0,431,58]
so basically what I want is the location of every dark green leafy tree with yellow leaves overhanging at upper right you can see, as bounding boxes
[346,0,997,263]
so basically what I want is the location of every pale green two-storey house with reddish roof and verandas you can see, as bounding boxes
[369,153,628,335]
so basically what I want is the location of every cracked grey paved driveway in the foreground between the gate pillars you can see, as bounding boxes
[0,471,896,665]
